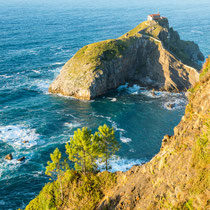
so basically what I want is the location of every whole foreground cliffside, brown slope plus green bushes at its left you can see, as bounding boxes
[26,57,210,210]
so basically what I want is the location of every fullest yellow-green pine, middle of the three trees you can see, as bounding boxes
[66,127,98,173]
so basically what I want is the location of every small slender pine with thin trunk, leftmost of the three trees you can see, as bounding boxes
[45,148,69,200]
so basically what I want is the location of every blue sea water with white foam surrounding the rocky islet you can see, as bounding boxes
[0,0,210,210]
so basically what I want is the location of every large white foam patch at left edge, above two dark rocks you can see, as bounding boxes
[0,125,39,150]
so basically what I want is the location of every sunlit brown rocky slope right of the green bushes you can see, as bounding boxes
[98,58,210,209]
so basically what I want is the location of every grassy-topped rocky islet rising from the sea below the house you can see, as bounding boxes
[49,20,203,100]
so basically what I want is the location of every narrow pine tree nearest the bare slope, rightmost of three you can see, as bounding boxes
[95,124,120,171]
